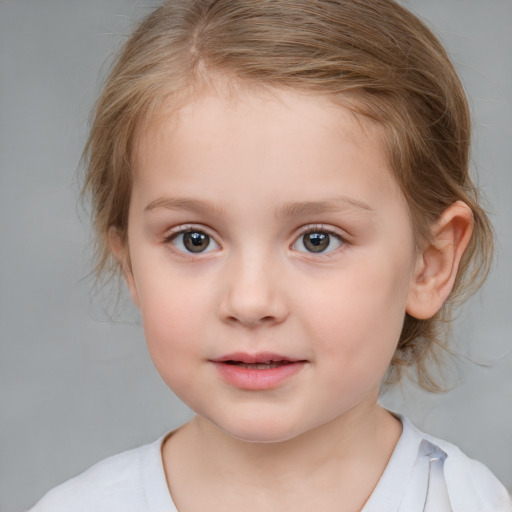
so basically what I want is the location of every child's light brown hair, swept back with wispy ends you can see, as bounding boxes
[83,0,493,391]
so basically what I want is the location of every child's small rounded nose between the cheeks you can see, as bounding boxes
[219,254,288,328]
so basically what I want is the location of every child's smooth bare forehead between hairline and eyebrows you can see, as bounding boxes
[134,89,404,212]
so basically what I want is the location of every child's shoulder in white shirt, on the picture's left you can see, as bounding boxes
[29,439,172,512]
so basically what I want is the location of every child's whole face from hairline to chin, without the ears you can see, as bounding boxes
[126,91,416,442]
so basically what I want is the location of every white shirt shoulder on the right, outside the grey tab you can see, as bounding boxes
[413,418,512,512]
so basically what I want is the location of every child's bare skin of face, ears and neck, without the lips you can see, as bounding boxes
[111,86,471,512]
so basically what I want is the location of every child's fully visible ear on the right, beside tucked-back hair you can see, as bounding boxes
[406,201,474,320]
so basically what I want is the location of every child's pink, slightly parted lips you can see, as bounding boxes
[212,352,307,391]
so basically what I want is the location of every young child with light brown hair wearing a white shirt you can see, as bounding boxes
[33,0,512,512]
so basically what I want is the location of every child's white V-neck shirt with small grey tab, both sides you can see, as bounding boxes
[29,417,512,512]
